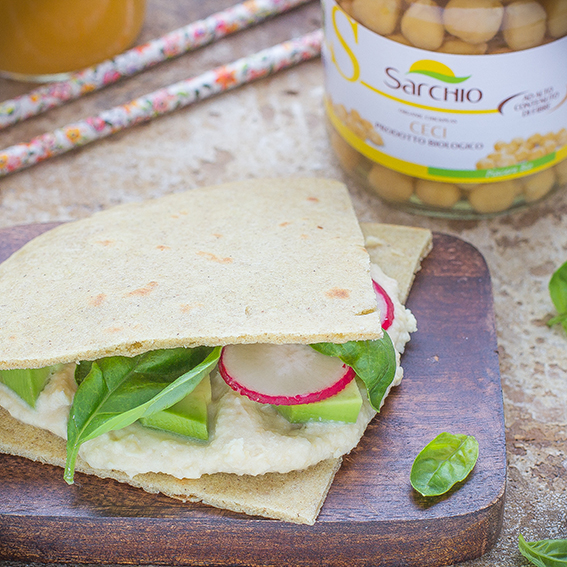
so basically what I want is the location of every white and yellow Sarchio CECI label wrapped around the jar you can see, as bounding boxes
[323,0,567,183]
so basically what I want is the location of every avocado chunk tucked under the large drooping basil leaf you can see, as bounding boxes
[139,376,211,441]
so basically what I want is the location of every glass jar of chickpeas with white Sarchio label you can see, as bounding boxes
[322,0,567,219]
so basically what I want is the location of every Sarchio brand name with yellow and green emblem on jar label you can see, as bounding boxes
[384,59,482,104]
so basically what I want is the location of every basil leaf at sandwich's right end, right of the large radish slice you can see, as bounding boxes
[311,333,396,411]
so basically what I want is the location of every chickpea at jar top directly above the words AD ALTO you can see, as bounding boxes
[502,0,547,51]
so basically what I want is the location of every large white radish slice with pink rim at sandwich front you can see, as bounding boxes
[219,344,355,406]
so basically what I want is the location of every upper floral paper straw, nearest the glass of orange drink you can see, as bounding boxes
[0,0,311,130]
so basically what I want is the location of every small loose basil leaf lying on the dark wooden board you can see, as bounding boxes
[410,433,478,496]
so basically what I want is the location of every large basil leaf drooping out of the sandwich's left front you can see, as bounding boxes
[64,347,221,484]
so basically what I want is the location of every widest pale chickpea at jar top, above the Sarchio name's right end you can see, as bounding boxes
[443,0,504,43]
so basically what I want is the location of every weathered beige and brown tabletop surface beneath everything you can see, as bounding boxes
[0,0,567,567]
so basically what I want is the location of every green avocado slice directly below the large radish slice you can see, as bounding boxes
[273,379,362,423]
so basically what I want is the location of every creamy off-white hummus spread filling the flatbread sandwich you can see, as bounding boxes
[0,265,416,478]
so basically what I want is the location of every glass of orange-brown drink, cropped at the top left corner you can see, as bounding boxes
[0,0,146,81]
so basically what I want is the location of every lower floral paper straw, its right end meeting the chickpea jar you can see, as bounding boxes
[0,30,323,177]
